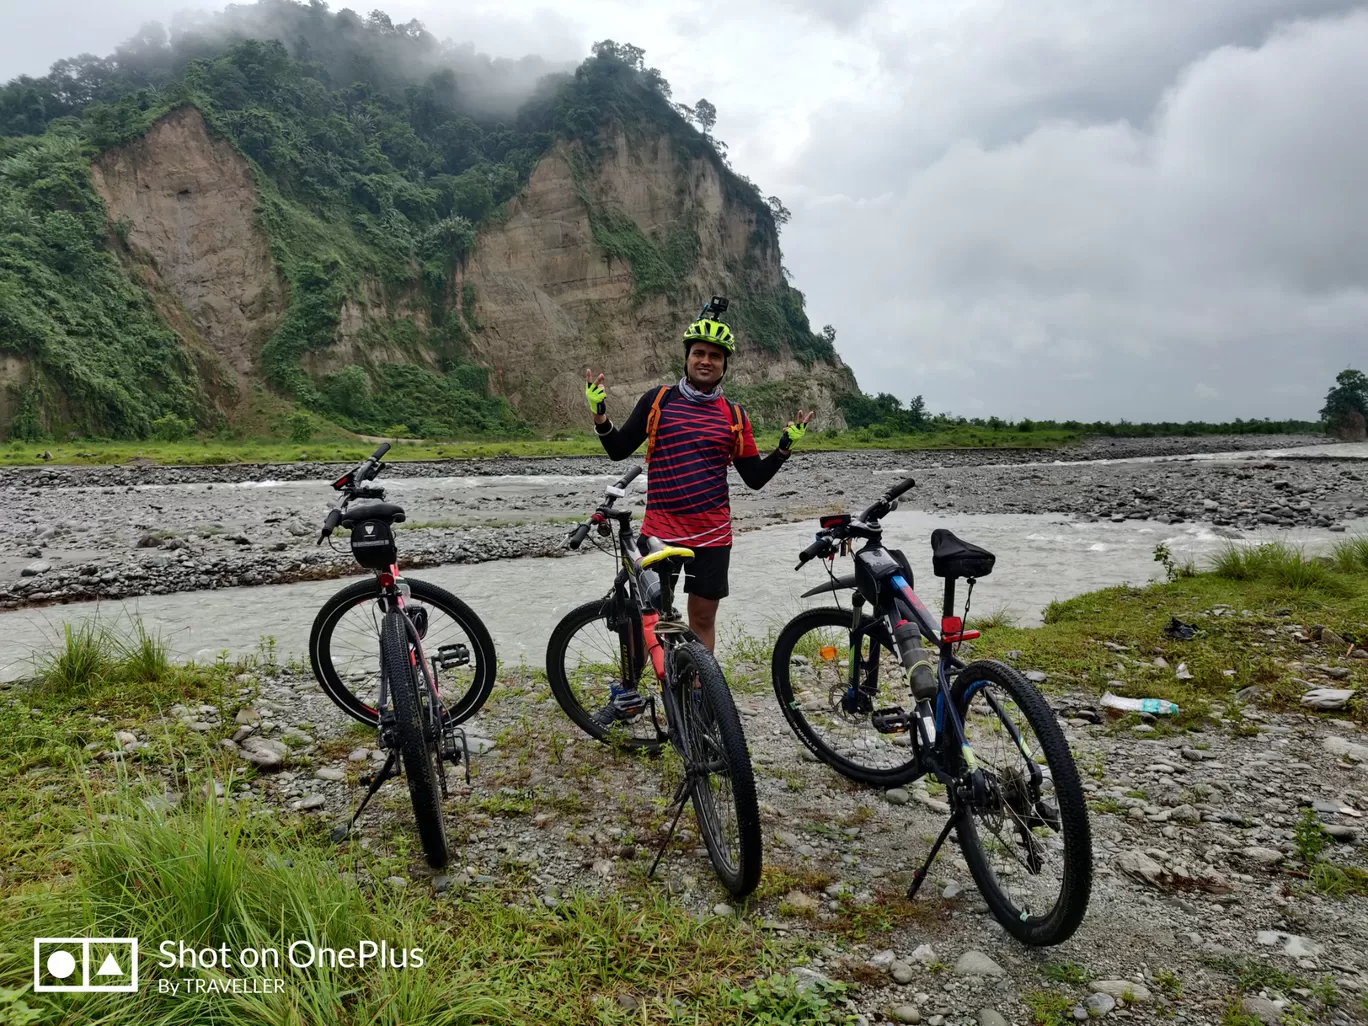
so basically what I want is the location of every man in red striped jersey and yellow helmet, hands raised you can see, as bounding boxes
[584,319,813,667]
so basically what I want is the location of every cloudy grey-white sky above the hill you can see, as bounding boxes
[0,0,1368,420]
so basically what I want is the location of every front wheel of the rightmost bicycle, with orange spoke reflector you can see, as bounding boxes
[770,607,921,788]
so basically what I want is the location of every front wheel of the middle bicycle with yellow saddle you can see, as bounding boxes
[546,595,661,752]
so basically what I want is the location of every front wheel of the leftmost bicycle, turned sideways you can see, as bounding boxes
[309,577,495,726]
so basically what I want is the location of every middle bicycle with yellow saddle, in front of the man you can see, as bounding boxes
[546,466,761,897]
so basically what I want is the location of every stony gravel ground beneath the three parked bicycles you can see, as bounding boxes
[64,642,1368,1026]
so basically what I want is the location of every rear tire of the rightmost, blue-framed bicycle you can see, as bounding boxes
[951,659,1092,947]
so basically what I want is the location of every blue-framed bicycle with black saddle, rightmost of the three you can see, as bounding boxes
[770,479,1092,947]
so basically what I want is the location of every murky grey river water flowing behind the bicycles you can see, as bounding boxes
[0,506,1341,680]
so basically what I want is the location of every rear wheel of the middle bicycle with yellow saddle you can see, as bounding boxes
[670,642,763,899]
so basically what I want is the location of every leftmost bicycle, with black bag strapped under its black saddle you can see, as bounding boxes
[309,443,495,869]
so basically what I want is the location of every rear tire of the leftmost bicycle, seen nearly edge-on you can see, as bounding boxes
[380,609,447,869]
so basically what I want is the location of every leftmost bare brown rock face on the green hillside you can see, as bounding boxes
[90,107,286,399]
